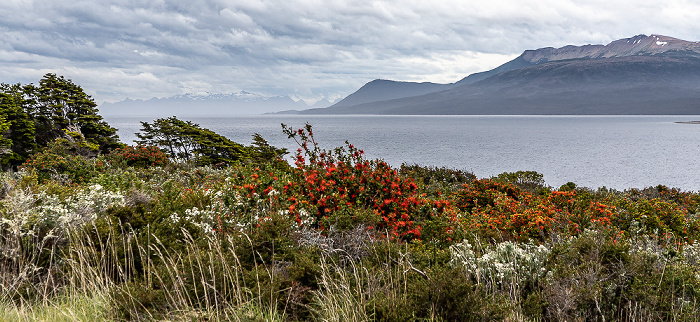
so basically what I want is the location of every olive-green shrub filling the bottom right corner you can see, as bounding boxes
[542,230,700,320]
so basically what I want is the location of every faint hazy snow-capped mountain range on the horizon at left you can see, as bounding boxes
[99,91,308,116]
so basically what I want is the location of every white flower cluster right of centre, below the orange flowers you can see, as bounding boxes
[450,241,551,285]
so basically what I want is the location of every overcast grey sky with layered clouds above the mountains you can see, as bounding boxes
[0,0,700,103]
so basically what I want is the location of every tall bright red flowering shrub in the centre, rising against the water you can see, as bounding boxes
[283,124,426,239]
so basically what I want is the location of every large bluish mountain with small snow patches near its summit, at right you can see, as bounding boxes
[303,35,700,114]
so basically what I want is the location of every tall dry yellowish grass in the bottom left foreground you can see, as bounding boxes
[0,218,285,321]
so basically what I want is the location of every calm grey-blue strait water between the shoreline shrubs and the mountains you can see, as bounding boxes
[105,115,700,191]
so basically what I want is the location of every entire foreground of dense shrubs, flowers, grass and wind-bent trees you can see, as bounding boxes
[0,75,700,321]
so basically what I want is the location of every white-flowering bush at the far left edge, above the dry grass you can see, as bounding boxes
[0,178,124,296]
